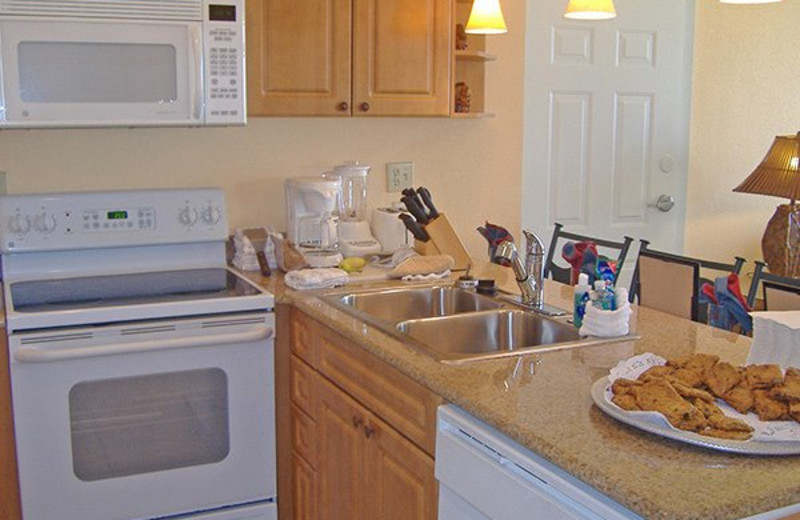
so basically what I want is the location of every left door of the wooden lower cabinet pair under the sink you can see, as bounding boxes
[315,377,372,520]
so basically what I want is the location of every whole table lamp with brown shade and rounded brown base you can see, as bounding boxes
[733,132,800,278]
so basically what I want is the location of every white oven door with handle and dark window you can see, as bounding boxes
[9,312,276,520]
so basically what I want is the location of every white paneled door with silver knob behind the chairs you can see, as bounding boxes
[522,0,694,282]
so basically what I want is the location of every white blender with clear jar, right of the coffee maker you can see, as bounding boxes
[323,161,382,257]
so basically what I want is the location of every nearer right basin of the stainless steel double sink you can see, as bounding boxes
[397,309,582,360]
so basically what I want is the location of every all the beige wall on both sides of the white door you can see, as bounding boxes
[0,0,800,268]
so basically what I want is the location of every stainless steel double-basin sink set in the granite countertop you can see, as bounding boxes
[322,285,619,363]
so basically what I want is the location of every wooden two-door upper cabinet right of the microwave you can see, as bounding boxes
[246,0,453,116]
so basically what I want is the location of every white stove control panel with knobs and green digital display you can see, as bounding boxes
[0,188,228,253]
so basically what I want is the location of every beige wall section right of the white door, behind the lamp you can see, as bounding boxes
[686,0,800,272]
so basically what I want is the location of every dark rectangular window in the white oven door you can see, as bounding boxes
[69,368,230,481]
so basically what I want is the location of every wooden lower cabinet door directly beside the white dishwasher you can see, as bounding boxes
[363,416,438,520]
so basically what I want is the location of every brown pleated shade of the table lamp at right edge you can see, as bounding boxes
[733,132,800,204]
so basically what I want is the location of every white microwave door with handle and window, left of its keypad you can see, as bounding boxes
[0,17,204,127]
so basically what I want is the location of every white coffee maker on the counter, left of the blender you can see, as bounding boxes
[286,177,342,267]
